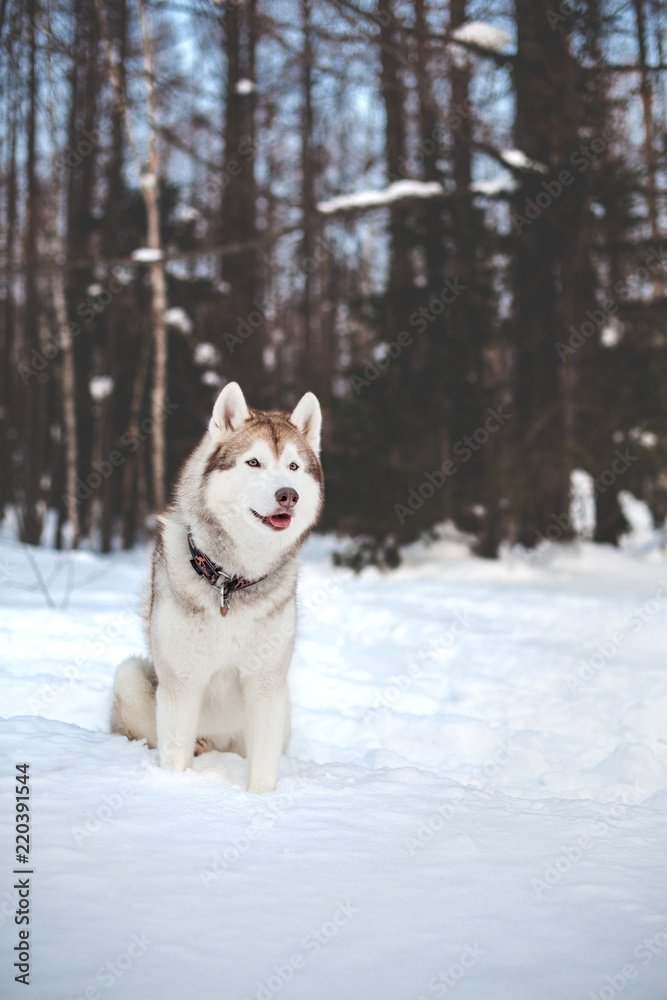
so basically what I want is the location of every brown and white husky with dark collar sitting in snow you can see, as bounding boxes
[111,382,323,792]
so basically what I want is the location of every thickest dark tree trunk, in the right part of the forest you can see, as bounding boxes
[513,0,589,547]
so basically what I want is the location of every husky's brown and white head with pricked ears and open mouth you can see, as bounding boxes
[202,382,323,554]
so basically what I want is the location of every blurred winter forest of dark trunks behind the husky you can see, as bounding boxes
[5,0,667,568]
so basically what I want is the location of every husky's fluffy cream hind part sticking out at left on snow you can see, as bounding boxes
[111,656,157,748]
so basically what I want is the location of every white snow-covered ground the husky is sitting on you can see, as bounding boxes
[0,538,667,1000]
